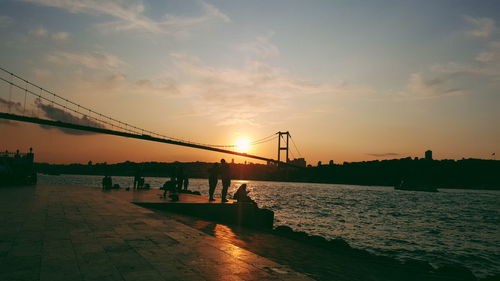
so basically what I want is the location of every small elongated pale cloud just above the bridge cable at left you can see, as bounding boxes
[47,52,126,70]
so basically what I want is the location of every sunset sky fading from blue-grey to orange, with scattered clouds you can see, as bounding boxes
[0,0,500,165]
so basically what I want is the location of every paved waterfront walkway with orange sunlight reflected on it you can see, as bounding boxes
[0,185,312,281]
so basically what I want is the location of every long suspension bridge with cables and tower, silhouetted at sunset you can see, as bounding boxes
[0,67,301,167]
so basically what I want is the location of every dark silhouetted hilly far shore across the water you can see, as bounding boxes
[35,157,500,190]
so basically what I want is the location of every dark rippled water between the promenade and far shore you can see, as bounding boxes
[38,174,500,277]
